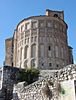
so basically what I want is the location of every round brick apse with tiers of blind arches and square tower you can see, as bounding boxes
[5,10,73,70]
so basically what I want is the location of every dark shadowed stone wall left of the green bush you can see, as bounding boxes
[0,66,19,100]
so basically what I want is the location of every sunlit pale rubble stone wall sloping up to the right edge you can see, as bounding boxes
[12,65,76,100]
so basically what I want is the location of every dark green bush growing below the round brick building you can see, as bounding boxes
[18,68,39,84]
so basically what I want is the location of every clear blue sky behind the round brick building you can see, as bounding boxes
[0,0,76,66]
